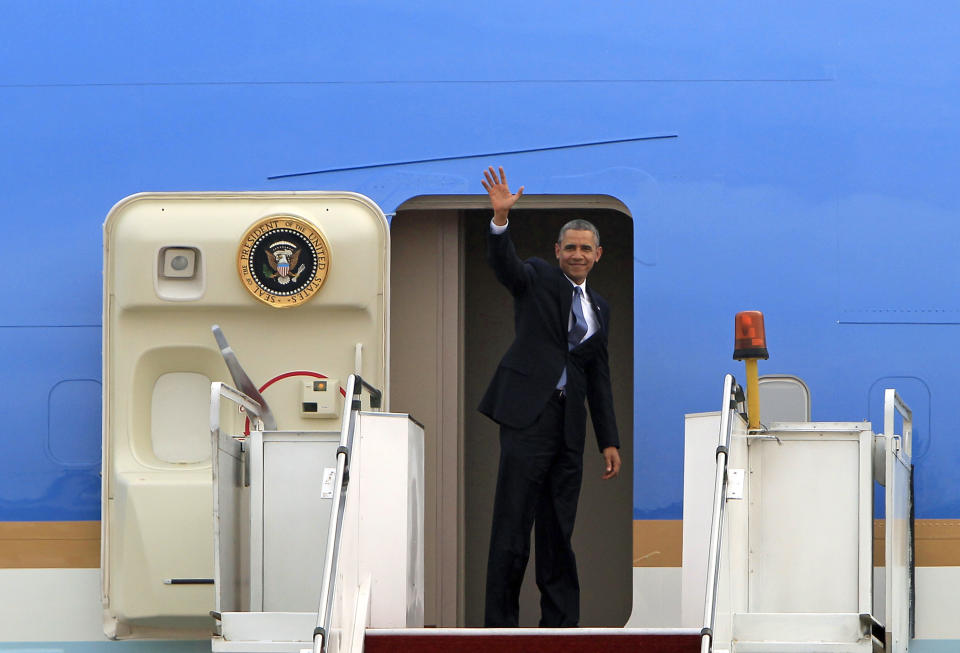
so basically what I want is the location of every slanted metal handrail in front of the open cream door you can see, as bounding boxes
[313,374,382,653]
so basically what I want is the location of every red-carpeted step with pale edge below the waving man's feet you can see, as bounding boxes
[364,628,700,653]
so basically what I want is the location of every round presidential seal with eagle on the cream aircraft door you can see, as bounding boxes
[237,215,330,308]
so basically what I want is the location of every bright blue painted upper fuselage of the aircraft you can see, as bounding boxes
[0,0,960,521]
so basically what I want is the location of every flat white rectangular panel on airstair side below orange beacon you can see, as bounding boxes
[748,435,860,613]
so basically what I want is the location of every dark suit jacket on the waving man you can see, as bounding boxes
[480,229,620,451]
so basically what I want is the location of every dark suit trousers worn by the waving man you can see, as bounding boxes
[484,397,583,627]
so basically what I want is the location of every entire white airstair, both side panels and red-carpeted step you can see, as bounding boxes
[211,366,913,653]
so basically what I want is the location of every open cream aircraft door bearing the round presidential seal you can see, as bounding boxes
[101,192,389,637]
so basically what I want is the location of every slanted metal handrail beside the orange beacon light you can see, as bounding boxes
[700,374,744,653]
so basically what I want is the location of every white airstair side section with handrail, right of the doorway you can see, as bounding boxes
[683,375,913,653]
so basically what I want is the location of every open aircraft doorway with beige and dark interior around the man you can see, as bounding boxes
[390,195,634,627]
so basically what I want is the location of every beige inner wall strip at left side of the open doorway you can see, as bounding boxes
[390,210,463,627]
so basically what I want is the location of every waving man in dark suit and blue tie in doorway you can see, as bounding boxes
[480,166,620,627]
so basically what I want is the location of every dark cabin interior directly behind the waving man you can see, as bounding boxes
[463,208,634,627]
